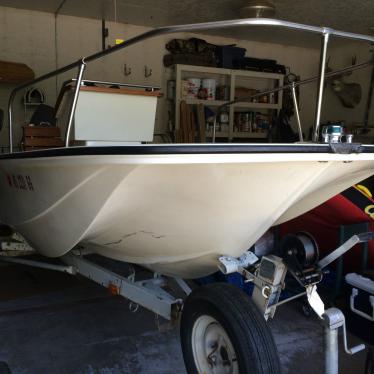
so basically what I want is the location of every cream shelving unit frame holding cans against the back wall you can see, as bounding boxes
[174,65,284,141]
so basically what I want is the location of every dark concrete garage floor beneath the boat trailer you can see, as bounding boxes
[0,266,366,374]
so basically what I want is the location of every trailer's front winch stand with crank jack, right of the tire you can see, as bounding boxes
[219,232,374,374]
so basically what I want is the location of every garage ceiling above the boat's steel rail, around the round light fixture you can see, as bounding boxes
[0,0,374,45]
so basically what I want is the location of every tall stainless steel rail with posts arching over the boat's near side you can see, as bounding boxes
[8,18,374,153]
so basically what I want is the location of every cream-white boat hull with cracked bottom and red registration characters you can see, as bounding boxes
[0,147,374,278]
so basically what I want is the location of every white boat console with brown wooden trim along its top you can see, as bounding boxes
[55,81,160,146]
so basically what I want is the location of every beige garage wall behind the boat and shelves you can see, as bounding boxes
[0,7,369,150]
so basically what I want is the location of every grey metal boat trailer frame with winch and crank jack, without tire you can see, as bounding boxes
[0,232,374,374]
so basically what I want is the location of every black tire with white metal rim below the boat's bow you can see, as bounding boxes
[180,283,280,374]
